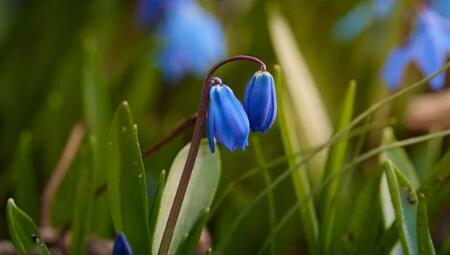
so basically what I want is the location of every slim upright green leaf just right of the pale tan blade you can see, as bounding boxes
[319,82,356,254]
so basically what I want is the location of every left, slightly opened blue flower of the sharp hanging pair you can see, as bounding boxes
[207,84,250,153]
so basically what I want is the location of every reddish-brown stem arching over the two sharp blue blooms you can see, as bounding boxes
[158,55,266,255]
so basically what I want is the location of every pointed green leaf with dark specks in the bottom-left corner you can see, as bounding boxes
[6,198,50,255]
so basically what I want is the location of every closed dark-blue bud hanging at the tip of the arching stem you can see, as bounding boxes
[244,71,277,132]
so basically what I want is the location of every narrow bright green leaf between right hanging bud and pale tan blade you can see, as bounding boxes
[275,66,319,250]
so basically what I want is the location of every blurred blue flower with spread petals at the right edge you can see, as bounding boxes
[383,9,450,90]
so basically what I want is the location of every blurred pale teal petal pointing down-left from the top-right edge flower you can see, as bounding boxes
[333,2,375,41]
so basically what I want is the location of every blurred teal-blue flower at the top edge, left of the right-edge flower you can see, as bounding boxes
[333,0,395,41]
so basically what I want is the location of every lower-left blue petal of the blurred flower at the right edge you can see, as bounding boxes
[383,46,411,90]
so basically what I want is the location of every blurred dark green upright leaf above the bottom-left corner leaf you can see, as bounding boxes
[12,131,40,220]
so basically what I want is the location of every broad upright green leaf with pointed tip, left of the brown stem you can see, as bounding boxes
[108,102,151,254]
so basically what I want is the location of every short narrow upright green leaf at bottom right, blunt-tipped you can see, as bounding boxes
[417,194,436,255]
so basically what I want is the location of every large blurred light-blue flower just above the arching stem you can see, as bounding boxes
[158,1,225,82]
